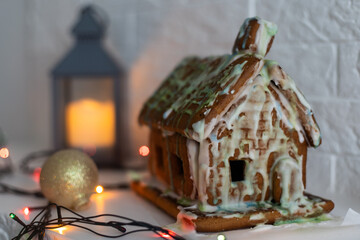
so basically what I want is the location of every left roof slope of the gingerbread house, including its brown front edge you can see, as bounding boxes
[140,54,263,139]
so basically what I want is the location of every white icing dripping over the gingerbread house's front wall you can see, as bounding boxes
[188,68,303,210]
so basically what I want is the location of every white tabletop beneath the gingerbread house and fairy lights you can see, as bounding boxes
[0,143,360,240]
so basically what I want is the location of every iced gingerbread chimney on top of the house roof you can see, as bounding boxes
[232,17,277,57]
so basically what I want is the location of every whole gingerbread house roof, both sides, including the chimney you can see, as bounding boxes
[139,18,320,146]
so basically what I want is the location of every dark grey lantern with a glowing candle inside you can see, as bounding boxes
[52,6,126,167]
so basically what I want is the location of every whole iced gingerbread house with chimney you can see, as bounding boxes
[139,17,333,231]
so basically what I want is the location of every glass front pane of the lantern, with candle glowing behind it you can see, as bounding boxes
[64,78,116,156]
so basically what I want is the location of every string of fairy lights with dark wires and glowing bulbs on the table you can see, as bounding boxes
[0,148,188,240]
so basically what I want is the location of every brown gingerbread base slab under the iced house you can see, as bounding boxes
[131,182,334,232]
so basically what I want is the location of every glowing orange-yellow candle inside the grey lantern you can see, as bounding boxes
[66,99,115,147]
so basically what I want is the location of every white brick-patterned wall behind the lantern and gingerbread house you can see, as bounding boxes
[0,0,360,200]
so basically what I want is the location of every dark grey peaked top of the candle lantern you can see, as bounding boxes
[52,6,121,77]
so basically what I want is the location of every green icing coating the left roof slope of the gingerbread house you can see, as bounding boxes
[142,54,252,138]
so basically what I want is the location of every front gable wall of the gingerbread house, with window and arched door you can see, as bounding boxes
[190,60,320,209]
